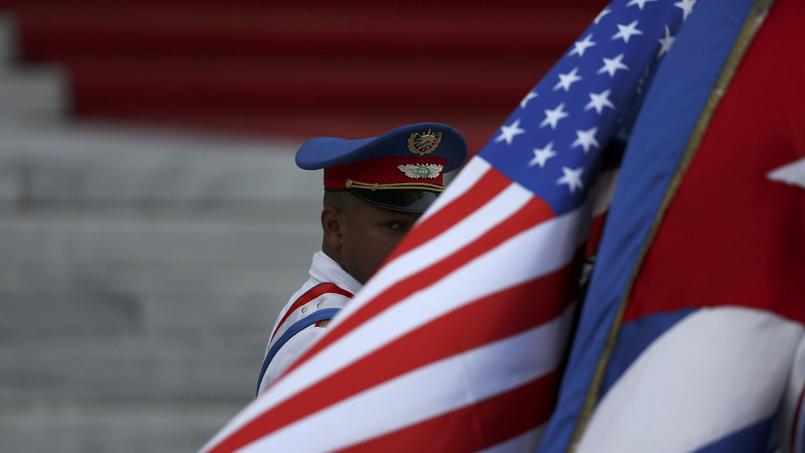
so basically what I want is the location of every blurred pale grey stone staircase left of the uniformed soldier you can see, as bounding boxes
[0,13,321,453]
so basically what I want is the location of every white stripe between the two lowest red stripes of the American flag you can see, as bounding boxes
[244,306,573,452]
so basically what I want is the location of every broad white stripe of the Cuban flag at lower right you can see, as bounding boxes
[577,307,802,453]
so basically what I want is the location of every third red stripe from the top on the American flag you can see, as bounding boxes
[211,249,581,452]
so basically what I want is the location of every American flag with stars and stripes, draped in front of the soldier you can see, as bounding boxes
[204,0,693,452]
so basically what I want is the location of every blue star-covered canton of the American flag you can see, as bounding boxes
[481,0,695,215]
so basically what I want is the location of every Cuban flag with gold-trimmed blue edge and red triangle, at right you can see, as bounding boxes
[539,0,805,453]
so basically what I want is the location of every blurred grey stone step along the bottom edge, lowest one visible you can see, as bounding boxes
[0,402,239,453]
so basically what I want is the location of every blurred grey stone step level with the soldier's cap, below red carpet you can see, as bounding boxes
[0,122,312,204]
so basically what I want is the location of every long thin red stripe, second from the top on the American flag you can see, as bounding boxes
[292,198,554,378]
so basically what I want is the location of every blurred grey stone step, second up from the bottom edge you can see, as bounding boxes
[0,332,266,400]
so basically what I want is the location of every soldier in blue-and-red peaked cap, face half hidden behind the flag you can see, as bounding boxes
[257,123,467,394]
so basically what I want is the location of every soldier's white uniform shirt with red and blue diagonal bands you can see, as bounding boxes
[257,250,361,395]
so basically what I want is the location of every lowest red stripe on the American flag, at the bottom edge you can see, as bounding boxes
[338,371,559,453]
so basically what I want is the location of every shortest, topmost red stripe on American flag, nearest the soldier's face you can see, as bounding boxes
[385,168,511,262]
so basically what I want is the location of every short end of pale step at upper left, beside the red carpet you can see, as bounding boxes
[0,64,68,123]
